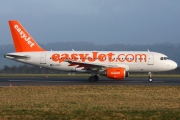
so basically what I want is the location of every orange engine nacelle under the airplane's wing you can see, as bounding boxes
[100,68,126,80]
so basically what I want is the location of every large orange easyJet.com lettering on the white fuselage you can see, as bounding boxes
[51,52,146,63]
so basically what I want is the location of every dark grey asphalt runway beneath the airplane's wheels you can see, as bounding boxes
[0,77,180,87]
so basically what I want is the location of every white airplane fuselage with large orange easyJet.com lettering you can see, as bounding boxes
[5,51,177,72]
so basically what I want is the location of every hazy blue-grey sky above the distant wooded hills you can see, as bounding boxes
[0,0,180,45]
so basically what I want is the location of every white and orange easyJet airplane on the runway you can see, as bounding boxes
[4,20,177,82]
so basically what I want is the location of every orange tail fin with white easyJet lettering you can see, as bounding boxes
[9,20,45,52]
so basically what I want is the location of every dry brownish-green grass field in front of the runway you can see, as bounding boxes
[0,86,180,120]
